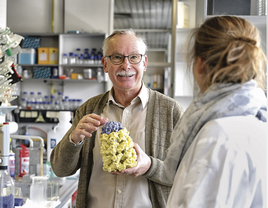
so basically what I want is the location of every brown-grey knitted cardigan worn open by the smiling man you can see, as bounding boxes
[50,90,183,208]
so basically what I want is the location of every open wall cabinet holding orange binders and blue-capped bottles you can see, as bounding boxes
[18,33,106,80]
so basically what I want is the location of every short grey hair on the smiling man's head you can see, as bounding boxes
[102,28,147,56]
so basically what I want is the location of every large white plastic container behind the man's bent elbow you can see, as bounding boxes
[47,111,72,161]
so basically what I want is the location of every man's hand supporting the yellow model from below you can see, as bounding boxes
[112,143,152,178]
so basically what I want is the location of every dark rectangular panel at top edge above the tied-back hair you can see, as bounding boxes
[207,0,251,15]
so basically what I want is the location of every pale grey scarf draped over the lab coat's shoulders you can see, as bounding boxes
[164,80,267,180]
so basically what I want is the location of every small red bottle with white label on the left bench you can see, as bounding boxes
[19,144,30,177]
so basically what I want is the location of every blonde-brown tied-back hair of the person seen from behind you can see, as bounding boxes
[187,16,266,89]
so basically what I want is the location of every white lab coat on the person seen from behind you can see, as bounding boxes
[167,116,268,208]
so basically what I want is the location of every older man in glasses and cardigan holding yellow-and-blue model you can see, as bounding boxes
[51,30,183,208]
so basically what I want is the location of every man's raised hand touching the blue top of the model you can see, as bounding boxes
[71,113,108,144]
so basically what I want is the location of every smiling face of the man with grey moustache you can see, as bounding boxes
[104,34,147,93]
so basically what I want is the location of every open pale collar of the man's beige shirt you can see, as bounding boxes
[107,81,149,108]
